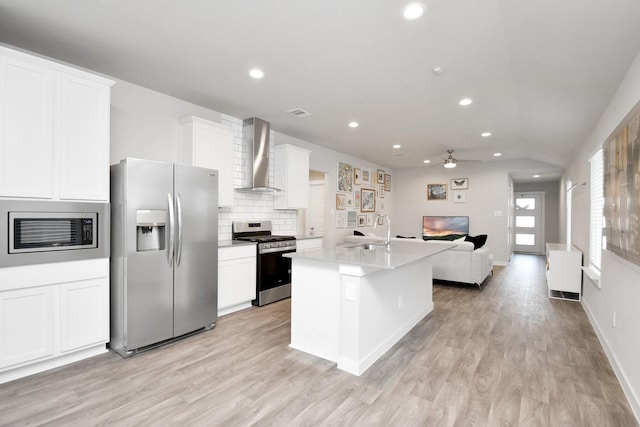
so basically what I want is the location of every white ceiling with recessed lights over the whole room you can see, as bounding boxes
[0,0,640,180]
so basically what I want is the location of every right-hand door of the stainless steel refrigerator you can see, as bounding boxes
[173,165,218,336]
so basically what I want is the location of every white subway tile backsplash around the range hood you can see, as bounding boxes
[218,114,297,240]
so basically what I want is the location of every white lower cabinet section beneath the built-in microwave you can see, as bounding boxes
[0,258,109,383]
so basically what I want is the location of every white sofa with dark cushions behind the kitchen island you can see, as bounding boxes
[344,236,493,287]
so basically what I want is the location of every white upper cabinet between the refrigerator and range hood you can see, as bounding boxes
[180,116,233,207]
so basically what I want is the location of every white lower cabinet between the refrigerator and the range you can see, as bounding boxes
[218,245,256,316]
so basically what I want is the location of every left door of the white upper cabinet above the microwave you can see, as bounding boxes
[0,56,57,198]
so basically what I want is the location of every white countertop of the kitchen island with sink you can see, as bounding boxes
[283,242,455,269]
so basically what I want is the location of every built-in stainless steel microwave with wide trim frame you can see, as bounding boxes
[0,200,109,267]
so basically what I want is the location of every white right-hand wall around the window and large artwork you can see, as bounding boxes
[565,48,640,417]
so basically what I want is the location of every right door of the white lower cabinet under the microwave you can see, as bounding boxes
[60,278,109,353]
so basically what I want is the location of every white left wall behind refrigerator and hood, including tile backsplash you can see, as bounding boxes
[110,79,393,245]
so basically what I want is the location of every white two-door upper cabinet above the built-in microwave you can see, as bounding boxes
[0,46,114,201]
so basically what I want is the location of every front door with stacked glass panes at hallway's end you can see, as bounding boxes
[513,192,544,254]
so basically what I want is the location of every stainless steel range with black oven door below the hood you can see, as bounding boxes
[231,220,296,306]
